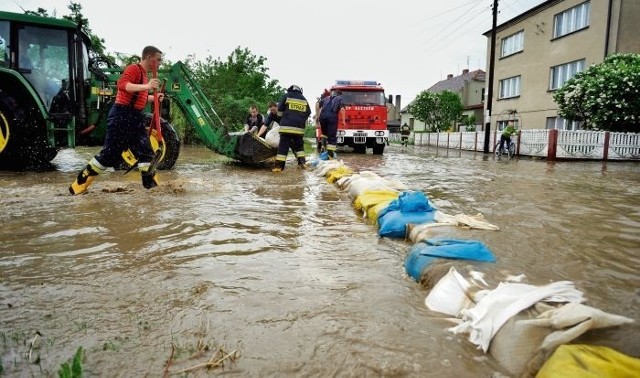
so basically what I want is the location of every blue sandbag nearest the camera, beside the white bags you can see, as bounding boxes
[404,239,496,281]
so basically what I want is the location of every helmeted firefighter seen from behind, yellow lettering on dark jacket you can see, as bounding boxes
[273,84,311,172]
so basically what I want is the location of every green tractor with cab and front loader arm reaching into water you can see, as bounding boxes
[0,12,276,169]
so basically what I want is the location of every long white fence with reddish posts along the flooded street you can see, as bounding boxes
[389,129,640,160]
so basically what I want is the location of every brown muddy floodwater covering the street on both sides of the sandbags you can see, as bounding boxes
[0,147,640,377]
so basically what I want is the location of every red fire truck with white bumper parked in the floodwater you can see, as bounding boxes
[318,80,389,155]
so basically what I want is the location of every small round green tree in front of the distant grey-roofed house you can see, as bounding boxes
[407,91,464,132]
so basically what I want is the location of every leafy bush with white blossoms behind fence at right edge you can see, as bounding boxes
[553,54,640,132]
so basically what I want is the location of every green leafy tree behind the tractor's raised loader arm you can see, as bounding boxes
[187,47,284,130]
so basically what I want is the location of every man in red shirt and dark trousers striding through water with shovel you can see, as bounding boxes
[69,46,163,195]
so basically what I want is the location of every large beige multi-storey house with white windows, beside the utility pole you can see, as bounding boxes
[484,0,640,130]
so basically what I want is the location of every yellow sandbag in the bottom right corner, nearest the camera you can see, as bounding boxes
[536,344,640,378]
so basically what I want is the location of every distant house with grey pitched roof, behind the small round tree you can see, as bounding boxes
[400,69,485,131]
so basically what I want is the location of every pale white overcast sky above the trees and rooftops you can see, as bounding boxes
[6,0,544,106]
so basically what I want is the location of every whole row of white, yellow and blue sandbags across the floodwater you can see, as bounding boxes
[311,159,640,377]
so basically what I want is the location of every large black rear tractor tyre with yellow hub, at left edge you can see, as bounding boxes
[0,88,58,170]
